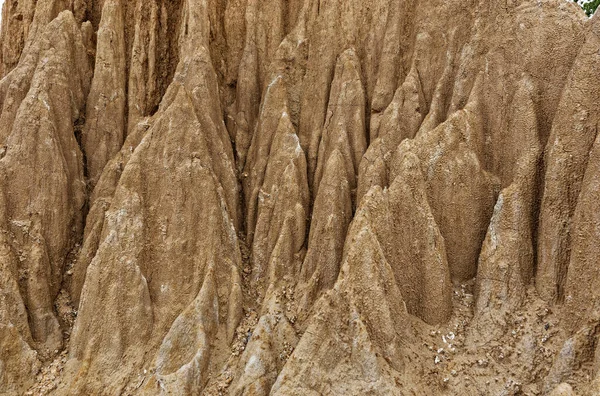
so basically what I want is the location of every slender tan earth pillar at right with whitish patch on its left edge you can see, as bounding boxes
[470,78,541,344]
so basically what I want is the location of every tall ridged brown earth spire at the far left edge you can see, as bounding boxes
[0,6,91,356]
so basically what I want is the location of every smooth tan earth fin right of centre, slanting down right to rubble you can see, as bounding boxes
[382,153,452,324]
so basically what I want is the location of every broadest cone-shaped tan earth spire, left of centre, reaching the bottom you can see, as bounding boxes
[71,87,241,391]
